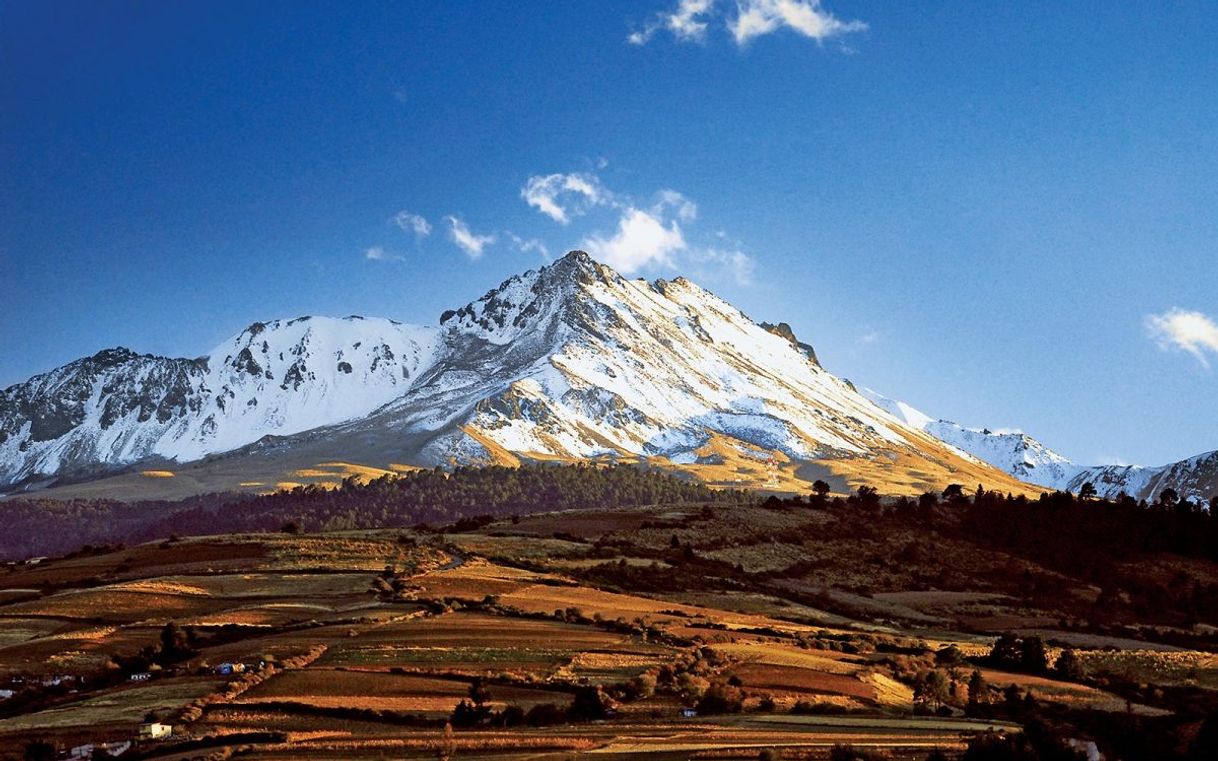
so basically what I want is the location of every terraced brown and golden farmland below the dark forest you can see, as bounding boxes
[0,475,1218,759]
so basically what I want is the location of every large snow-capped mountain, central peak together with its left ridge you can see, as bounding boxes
[0,252,1019,493]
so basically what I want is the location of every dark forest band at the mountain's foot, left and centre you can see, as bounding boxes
[0,465,753,559]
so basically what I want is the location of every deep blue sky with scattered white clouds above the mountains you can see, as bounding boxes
[0,0,1218,464]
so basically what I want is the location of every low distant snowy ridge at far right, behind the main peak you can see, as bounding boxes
[860,388,1218,502]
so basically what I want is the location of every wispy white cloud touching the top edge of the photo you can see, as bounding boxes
[626,0,867,46]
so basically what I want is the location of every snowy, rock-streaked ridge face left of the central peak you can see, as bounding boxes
[0,317,437,485]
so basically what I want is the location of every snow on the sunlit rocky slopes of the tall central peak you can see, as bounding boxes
[370,254,910,460]
